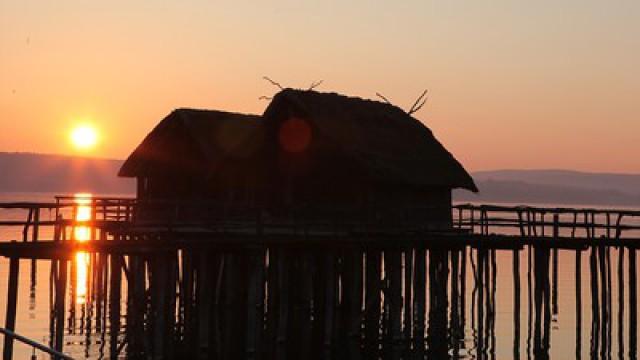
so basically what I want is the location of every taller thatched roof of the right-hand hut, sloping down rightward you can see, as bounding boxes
[263,89,478,192]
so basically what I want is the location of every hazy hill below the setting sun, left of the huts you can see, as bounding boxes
[0,152,135,194]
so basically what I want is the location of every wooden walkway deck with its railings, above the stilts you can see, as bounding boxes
[0,200,640,259]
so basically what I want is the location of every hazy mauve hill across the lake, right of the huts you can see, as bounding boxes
[454,170,640,207]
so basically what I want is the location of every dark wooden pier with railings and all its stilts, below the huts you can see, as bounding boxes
[0,197,640,359]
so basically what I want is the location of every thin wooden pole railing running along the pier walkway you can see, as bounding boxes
[0,196,640,242]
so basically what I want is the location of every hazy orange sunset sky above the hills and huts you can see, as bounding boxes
[0,0,640,173]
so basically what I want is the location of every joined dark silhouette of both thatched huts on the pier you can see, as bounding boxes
[119,89,477,224]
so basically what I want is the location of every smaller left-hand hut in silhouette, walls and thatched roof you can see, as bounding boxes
[118,109,260,201]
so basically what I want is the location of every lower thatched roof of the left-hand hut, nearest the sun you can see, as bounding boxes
[118,109,260,177]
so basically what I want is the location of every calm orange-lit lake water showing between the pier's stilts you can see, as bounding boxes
[0,194,640,359]
